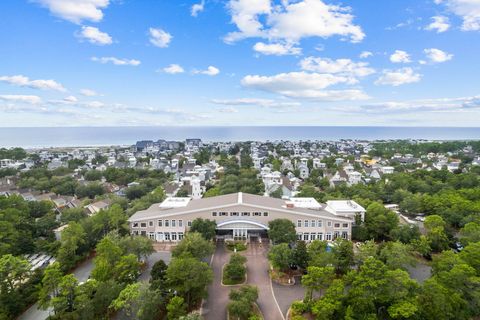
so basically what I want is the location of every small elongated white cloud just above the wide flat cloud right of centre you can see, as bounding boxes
[300,57,375,83]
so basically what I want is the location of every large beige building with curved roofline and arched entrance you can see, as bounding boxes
[128,192,365,241]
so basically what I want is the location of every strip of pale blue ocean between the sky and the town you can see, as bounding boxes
[0,126,480,148]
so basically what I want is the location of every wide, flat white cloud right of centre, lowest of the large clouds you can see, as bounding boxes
[241,72,368,101]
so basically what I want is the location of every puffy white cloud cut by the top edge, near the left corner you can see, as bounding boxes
[33,0,110,23]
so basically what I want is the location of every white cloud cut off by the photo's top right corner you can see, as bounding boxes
[435,0,480,31]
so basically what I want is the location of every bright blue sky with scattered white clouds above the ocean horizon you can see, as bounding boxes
[0,0,480,127]
